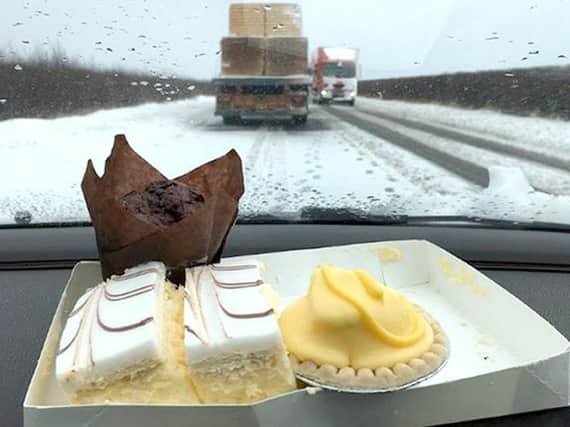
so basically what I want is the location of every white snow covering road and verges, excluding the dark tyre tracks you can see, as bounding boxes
[0,97,570,223]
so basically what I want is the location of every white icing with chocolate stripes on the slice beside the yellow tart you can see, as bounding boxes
[184,260,281,364]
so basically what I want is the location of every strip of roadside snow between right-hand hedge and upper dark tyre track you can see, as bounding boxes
[357,97,570,160]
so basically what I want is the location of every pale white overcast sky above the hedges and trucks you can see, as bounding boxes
[0,0,570,78]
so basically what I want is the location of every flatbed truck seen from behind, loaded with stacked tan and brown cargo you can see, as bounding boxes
[212,3,311,124]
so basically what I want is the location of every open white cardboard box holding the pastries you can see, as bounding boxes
[24,241,570,427]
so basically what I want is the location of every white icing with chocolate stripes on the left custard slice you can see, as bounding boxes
[56,262,166,391]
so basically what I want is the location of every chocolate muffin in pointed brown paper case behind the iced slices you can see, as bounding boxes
[81,135,244,279]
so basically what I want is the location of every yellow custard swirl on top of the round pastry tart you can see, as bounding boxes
[279,265,433,369]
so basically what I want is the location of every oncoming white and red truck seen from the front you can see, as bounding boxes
[311,47,359,106]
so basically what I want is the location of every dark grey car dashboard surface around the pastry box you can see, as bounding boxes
[0,225,570,426]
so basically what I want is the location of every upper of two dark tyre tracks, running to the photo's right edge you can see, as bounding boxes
[357,107,570,172]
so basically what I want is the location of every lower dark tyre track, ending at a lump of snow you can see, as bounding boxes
[326,107,489,187]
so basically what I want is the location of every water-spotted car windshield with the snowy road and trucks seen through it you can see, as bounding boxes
[0,0,570,228]
